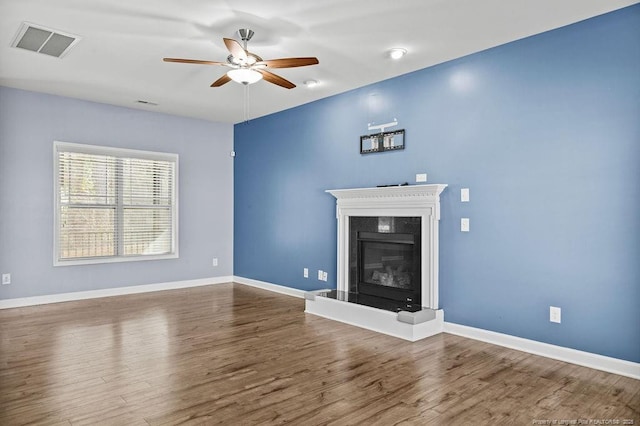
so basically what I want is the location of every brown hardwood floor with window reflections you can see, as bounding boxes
[0,284,640,425]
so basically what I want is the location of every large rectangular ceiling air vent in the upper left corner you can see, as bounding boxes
[11,22,80,58]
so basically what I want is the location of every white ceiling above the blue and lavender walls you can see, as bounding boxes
[0,0,638,123]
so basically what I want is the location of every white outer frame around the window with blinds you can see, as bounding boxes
[53,141,179,266]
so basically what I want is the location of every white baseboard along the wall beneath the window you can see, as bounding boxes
[0,276,233,309]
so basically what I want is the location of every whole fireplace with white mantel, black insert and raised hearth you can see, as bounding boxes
[305,184,447,341]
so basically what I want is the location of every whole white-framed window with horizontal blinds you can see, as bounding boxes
[54,142,178,265]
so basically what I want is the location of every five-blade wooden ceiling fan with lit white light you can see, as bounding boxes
[163,28,319,89]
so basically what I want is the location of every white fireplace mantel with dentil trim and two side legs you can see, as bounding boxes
[326,184,447,309]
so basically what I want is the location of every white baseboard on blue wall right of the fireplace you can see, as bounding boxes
[444,321,640,379]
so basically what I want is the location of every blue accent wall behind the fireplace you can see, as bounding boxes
[234,5,640,362]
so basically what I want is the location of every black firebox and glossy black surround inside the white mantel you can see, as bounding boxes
[349,216,422,307]
